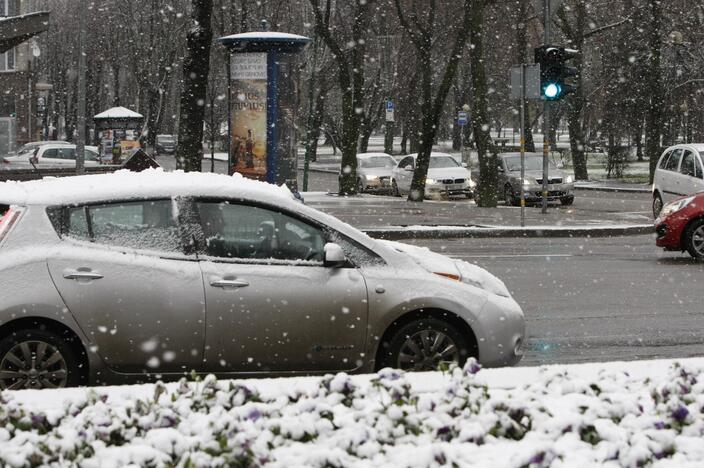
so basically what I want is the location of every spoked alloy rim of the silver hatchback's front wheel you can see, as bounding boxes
[396,330,460,371]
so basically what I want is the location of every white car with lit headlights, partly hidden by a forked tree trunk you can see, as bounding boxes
[391,153,474,198]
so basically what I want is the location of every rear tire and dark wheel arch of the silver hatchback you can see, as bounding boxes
[0,329,87,390]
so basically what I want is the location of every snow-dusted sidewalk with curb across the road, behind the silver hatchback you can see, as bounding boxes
[303,192,654,239]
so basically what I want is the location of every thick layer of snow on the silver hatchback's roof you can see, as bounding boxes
[0,168,298,205]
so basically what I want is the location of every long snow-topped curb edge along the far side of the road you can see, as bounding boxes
[362,224,655,240]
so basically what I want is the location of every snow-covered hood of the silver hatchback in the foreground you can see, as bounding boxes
[377,240,511,298]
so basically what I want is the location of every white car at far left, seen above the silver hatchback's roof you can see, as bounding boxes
[2,144,100,169]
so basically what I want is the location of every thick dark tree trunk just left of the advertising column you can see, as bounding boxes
[176,0,213,171]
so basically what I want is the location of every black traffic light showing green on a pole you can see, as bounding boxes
[535,45,579,101]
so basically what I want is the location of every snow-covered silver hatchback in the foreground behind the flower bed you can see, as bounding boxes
[0,170,525,389]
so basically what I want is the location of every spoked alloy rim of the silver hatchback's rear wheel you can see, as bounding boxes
[0,340,68,390]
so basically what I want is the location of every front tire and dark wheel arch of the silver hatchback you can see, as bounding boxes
[377,317,476,372]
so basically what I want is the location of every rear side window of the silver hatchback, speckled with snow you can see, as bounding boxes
[65,200,181,252]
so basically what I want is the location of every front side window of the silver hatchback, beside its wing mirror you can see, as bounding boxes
[196,201,325,264]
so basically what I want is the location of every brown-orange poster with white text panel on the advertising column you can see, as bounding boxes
[230,53,267,180]
